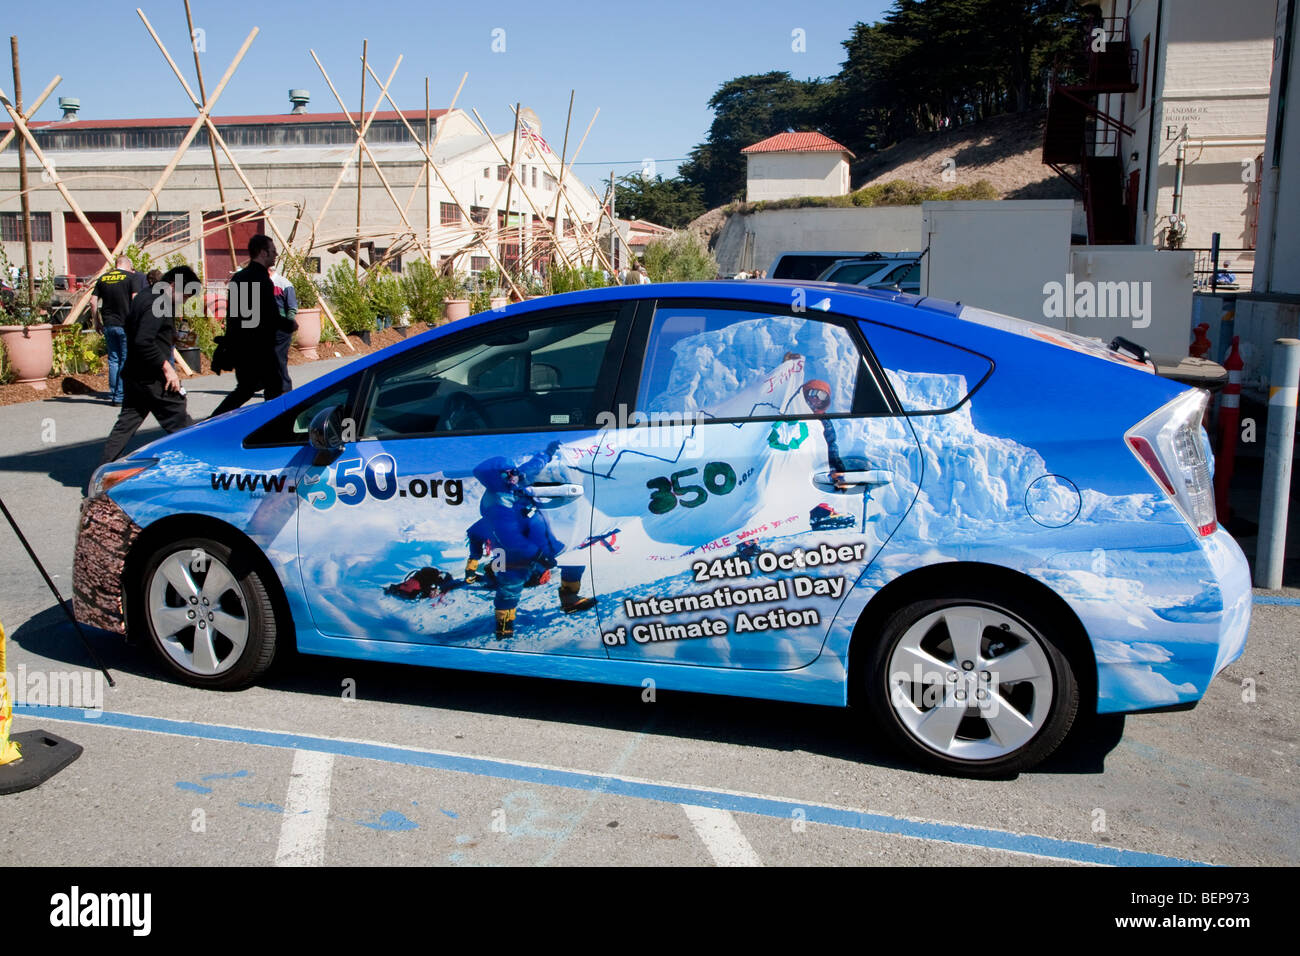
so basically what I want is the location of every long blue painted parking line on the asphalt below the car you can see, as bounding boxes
[13,705,1208,866]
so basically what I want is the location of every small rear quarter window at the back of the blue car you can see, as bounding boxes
[859,321,993,414]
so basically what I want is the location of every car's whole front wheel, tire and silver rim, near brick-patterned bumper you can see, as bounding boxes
[140,537,276,689]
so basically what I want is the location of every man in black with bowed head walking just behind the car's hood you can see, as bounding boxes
[100,265,200,464]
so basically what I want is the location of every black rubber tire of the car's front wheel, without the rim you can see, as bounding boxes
[133,537,278,691]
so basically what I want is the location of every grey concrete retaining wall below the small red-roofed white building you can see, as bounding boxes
[714,206,924,276]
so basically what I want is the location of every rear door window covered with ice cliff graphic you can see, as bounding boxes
[637,304,888,419]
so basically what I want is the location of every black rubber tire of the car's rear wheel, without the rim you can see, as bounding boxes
[863,594,1079,778]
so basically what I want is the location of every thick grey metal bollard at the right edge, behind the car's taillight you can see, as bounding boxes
[1255,338,1300,588]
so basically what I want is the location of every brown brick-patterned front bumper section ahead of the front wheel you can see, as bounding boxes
[73,494,140,635]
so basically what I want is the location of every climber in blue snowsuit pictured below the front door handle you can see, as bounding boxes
[465,447,595,640]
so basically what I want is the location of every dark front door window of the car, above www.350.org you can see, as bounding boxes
[361,311,618,438]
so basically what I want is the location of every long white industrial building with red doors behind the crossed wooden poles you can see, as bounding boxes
[0,91,601,282]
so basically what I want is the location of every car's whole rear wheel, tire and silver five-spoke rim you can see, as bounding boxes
[867,597,1079,777]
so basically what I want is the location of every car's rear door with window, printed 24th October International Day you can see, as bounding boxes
[588,300,922,670]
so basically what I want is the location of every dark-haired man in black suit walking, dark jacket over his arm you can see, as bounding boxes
[212,233,294,415]
